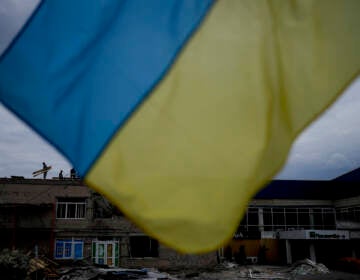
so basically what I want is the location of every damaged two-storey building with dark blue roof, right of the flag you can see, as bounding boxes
[225,168,360,266]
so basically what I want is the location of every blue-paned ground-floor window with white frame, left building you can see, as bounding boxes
[55,239,84,260]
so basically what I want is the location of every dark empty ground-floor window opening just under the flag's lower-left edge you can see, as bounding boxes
[130,235,159,258]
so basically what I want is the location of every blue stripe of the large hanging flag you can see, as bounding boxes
[0,0,212,176]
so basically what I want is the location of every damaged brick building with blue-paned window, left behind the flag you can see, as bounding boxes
[0,177,217,269]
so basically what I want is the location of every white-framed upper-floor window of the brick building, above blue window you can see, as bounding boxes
[56,198,86,219]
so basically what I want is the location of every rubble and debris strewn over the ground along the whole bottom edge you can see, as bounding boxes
[0,250,359,280]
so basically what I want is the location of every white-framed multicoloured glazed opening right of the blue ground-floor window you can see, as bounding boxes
[92,240,119,267]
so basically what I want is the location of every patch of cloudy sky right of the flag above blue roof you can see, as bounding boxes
[277,78,360,179]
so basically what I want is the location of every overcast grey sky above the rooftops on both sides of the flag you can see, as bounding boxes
[0,78,360,179]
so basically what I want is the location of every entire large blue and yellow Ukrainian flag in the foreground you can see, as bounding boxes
[0,0,360,253]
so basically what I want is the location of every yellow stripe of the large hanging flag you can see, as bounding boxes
[86,0,360,253]
